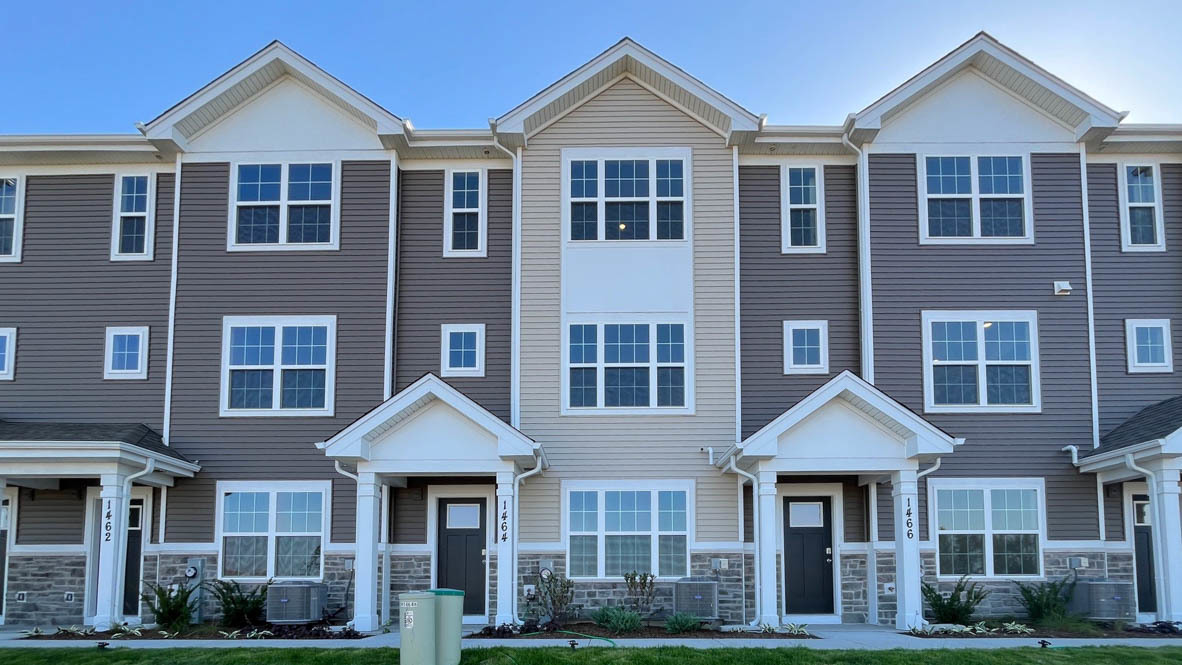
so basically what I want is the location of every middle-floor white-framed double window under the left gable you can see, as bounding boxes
[221,315,337,416]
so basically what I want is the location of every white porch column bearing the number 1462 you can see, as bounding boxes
[95,474,128,631]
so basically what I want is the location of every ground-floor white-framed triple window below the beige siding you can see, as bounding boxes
[563,481,694,579]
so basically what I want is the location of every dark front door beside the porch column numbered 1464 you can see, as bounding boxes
[435,498,488,615]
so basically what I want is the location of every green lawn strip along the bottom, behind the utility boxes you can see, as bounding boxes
[0,647,1182,665]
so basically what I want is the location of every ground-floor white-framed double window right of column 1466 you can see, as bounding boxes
[928,478,1046,578]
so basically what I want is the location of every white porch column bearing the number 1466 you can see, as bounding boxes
[890,469,923,631]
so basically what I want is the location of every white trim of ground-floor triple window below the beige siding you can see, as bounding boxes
[560,480,697,581]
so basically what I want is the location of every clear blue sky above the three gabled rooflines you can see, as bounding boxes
[0,0,1182,133]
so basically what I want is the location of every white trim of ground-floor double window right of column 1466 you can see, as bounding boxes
[928,476,1048,581]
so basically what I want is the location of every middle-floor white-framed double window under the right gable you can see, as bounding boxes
[922,309,1041,413]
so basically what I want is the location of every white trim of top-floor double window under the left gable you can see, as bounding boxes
[226,158,340,252]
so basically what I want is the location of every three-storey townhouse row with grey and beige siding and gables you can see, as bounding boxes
[0,33,1182,631]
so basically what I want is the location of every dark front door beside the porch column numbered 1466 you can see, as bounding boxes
[784,496,833,614]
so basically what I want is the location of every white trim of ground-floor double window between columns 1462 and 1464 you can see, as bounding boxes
[214,481,332,582]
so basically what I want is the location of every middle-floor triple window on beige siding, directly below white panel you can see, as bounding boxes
[566,324,690,410]
